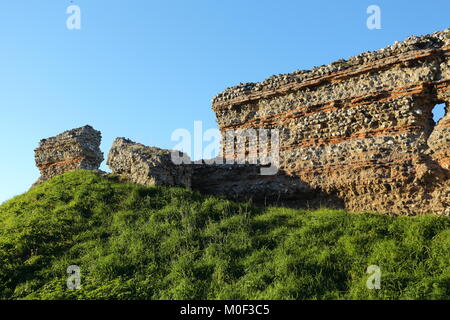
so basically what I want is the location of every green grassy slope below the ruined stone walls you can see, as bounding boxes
[0,171,450,299]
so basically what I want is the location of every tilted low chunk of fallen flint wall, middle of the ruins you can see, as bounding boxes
[107,138,192,188]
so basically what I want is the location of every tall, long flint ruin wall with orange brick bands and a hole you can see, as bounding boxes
[203,29,450,214]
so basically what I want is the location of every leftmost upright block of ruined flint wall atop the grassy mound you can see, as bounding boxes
[35,126,103,185]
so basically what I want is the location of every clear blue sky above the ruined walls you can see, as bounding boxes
[0,0,450,202]
